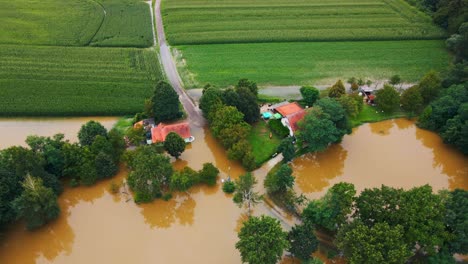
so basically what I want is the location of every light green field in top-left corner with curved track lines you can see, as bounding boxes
[0,0,153,47]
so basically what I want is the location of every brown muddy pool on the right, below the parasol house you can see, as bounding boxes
[292,119,468,198]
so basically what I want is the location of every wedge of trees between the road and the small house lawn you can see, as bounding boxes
[200,79,260,171]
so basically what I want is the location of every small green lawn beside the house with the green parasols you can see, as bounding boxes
[247,121,281,165]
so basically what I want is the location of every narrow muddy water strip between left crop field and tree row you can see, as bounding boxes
[0,117,118,149]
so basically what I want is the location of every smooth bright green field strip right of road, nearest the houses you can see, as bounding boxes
[177,40,450,88]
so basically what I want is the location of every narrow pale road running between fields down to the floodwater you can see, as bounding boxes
[154,0,206,127]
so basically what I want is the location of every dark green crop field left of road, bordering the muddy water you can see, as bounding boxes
[0,45,161,116]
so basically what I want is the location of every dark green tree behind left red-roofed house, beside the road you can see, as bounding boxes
[151,81,182,122]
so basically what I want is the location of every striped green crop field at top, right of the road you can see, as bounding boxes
[163,0,445,45]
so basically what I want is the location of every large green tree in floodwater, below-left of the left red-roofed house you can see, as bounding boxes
[127,150,173,203]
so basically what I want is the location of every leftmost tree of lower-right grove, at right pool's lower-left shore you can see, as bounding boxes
[302,182,356,232]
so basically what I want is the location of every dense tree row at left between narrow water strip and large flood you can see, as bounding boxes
[0,121,125,229]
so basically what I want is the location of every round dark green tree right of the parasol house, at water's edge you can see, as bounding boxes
[296,107,342,152]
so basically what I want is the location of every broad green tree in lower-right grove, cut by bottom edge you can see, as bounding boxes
[337,220,411,264]
